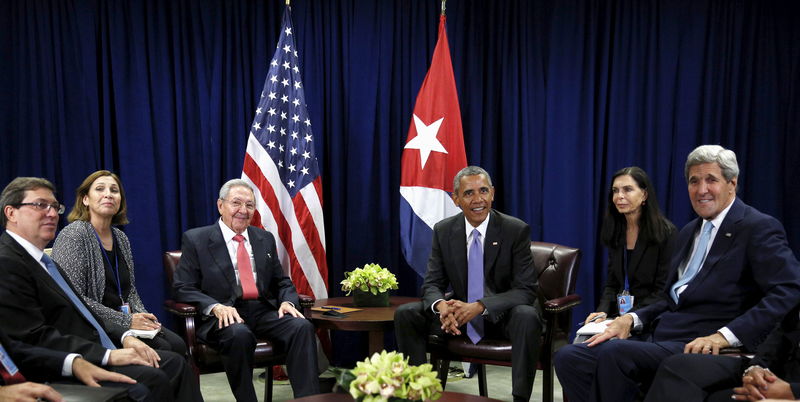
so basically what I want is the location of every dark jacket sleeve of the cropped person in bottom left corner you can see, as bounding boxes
[0,330,67,384]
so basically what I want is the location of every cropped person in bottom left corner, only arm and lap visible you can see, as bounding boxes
[0,331,142,401]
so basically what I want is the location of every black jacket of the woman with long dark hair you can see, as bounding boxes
[595,232,674,317]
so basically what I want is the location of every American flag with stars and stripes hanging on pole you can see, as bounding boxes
[242,6,328,299]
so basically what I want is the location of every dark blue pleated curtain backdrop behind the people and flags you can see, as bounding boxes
[0,0,800,362]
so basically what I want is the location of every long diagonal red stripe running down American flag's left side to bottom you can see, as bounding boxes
[242,152,314,295]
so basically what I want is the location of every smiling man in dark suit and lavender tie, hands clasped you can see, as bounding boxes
[394,166,542,401]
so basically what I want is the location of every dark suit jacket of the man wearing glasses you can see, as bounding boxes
[0,232,126,365]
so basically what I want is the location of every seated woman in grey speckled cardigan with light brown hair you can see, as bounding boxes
[52,170,186,355]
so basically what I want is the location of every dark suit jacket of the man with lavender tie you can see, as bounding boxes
[422,210,538,322]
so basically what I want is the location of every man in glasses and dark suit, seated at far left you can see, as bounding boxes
[0,177,202,401]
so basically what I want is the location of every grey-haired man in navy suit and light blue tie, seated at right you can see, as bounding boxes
[555,145,800,402]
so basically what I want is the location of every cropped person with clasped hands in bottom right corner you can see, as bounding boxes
[645,308,800,402]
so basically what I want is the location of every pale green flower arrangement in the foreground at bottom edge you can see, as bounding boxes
[337,350,442,402]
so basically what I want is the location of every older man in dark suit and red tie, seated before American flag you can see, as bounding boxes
[173,179,319,401]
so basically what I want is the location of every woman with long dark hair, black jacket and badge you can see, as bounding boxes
[584,166,675,323]
